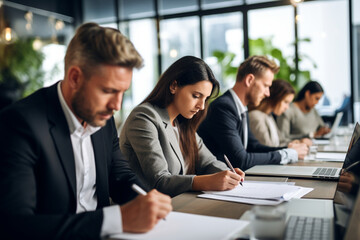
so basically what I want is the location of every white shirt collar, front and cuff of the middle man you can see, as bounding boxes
[229,89,298,164]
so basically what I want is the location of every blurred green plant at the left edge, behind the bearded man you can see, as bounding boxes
[0,39,45,97]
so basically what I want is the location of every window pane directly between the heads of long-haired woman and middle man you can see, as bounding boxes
[203,12,244,92]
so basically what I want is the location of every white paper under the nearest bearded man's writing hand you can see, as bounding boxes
[110,212,249,240]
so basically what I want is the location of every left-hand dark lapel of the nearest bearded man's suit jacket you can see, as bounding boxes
[46,83,76,199]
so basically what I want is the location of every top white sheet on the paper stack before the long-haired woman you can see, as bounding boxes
[204,182,300,200]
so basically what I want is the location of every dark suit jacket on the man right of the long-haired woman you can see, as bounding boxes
[197,91,282,170]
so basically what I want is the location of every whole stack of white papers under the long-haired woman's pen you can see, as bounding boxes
[198,181,313,205]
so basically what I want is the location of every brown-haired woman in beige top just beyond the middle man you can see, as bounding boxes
[249,79,312,148]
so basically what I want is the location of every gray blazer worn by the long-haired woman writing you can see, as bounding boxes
[120,103,228,196]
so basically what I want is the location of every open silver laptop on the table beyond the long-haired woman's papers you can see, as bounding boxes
[245,123,360,180]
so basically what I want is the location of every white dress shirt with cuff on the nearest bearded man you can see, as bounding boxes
[57,82,122,237]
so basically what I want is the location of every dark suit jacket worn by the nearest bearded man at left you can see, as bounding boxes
[0,84,143,239]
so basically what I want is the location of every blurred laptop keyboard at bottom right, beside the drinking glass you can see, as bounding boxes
[285,216,331,240]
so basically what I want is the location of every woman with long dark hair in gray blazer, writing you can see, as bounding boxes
[120,56,244,196]
